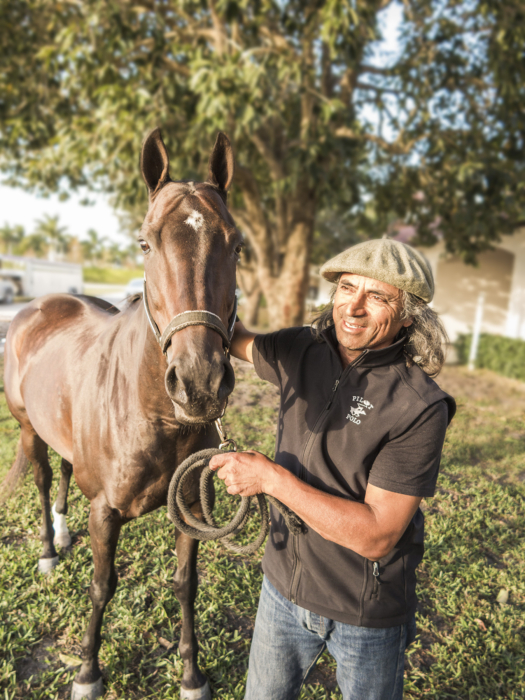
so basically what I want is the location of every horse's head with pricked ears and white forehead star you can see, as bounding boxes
[139,129,242,424]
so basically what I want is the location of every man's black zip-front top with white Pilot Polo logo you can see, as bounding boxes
[253,327,455,627]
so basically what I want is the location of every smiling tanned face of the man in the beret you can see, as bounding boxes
[333,272,412,365]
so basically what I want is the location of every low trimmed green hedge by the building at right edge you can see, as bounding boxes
[454,333,525,382]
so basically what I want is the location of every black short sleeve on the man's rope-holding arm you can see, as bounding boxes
[368,401,448,498]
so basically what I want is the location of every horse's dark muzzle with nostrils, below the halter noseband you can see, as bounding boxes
[165,353,235,424]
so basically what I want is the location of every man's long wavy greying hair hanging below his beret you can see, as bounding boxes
[312,284,449,377]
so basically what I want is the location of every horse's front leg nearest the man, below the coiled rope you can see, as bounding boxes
[174,503,211,700]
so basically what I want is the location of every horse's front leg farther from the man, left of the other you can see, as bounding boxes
[71,494,122,700]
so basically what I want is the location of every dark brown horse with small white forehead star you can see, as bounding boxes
[5,130,242,700]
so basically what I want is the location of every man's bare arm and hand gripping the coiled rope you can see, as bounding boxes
[210,451,421,561]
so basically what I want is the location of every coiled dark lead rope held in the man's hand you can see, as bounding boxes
[168,418,306,554]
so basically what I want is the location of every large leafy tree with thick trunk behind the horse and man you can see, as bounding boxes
[0,0,525,325]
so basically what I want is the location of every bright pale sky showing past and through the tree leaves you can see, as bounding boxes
[0,2,402,244]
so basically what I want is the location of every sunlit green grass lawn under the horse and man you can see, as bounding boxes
[0,358,525,700]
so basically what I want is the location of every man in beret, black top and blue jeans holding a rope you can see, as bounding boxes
[210,239,455,700]
